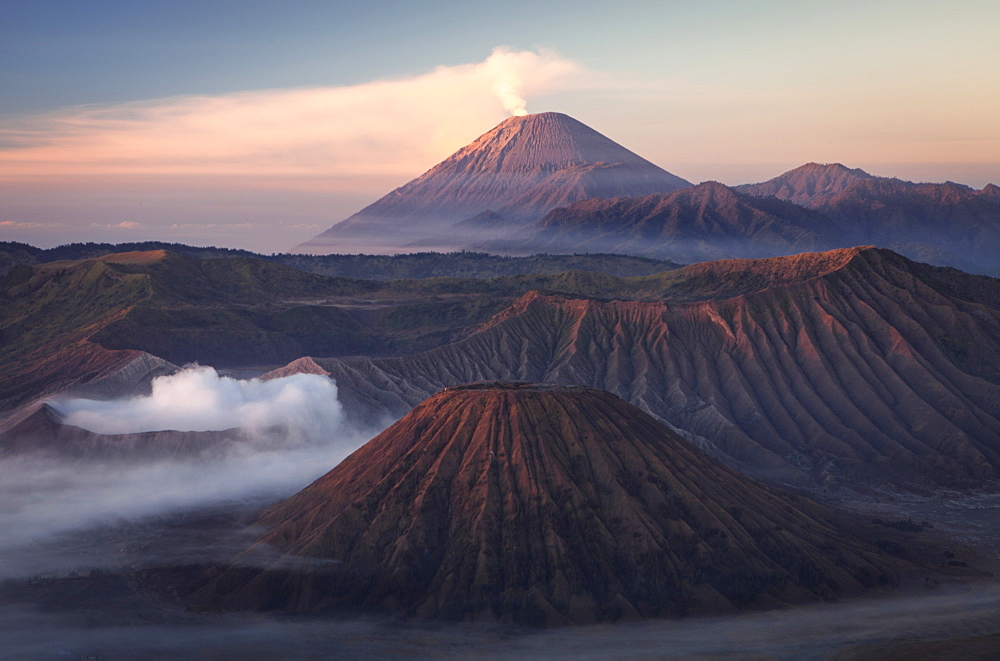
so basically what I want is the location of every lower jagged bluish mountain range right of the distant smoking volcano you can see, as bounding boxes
[488,163,1000,273]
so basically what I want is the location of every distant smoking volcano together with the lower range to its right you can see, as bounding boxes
[294,113,1000,273]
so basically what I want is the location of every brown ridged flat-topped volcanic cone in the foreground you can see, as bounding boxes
[197,383,894,624]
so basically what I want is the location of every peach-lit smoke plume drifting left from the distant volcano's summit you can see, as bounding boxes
[0,47,586,179]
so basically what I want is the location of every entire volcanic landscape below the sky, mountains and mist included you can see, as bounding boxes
[0,113,1000,658]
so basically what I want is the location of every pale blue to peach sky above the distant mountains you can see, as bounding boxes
[0,0,1000,249]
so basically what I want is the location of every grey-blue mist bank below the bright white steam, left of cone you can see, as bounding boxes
[0,438,370,568]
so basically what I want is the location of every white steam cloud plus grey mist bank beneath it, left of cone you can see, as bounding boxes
[0,367,377,578]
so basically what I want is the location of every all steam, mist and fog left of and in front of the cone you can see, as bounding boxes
[0,368,1000,659]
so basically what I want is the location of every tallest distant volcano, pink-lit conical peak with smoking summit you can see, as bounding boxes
[293,112,691,253]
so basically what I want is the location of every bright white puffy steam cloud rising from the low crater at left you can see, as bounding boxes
[54,366,343,440]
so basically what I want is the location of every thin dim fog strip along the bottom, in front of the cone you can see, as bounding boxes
[0,586,1000,659]
